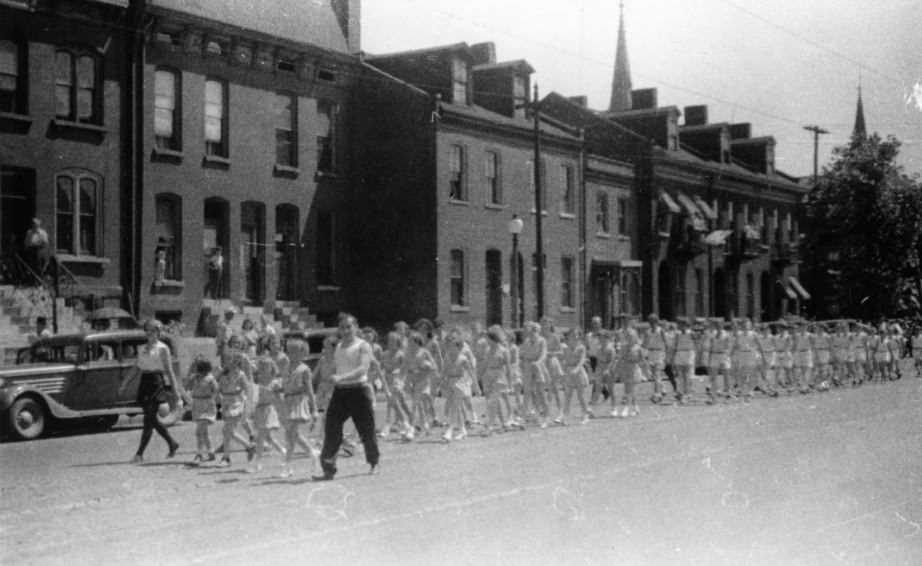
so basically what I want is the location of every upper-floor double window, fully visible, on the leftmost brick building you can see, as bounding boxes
[54,51,102,124]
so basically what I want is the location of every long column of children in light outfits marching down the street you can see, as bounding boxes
[174,315,922,476]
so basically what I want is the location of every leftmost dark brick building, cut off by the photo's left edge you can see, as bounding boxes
[0,0,131,316]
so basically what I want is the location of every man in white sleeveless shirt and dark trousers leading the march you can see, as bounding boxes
[314,314,380,481]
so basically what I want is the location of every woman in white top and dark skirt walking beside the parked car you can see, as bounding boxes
[124,320,179,462]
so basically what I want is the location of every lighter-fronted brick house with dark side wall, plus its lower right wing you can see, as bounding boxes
[349,43,632,326]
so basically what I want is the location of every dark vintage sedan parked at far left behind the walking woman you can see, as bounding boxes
[0,330,182,440]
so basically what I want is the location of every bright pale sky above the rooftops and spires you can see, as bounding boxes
[362,0,922,176]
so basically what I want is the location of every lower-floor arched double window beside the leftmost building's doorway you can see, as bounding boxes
[55,171,102,255]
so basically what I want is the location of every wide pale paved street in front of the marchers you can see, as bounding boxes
[0,372,922,565]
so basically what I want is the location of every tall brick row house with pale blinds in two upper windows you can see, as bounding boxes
[135,0,359,324]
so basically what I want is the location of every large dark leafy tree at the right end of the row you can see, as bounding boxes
[804,134,922,319]
